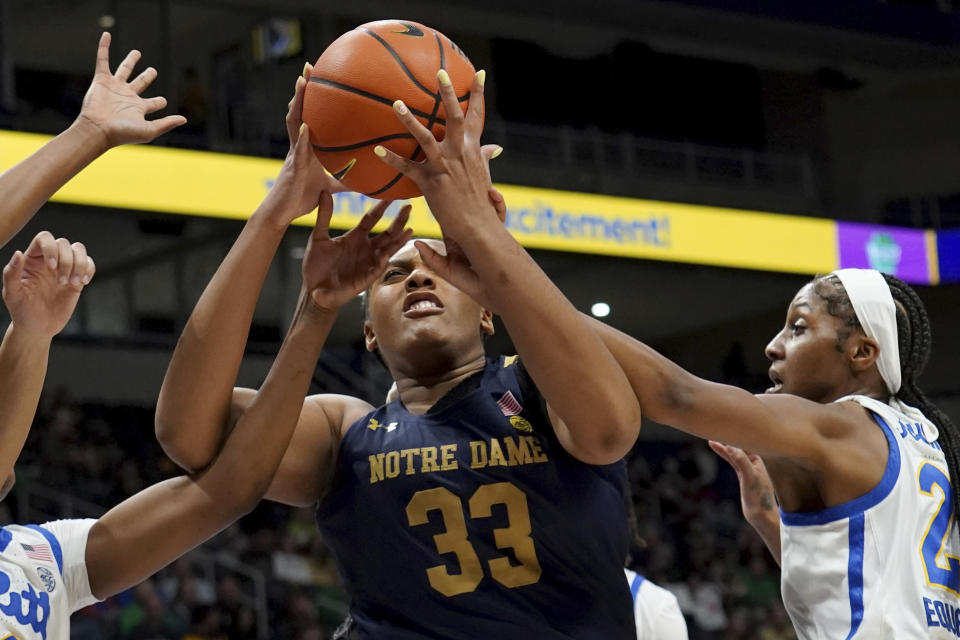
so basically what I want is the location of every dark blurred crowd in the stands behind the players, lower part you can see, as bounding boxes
[0,382,795,640]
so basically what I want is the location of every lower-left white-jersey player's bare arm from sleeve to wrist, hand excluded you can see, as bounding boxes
[87,296,336,598]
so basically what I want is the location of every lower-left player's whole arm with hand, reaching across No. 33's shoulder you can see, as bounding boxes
[86,194,409,598]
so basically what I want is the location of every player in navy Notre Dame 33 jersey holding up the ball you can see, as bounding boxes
[157,63,640,640]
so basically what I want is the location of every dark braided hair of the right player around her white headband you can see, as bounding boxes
[813,274,960,514]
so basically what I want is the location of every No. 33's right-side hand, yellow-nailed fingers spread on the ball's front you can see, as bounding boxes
[374,69,502,240]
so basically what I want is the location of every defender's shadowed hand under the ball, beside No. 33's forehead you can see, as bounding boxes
[302,192,412,311]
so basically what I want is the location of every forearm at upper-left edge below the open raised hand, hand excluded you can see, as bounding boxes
[0,118,108,245]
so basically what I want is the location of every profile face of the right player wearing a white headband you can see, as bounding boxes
[766,283,851,402]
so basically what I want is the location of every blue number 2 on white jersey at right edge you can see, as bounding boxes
[917,462,960,595]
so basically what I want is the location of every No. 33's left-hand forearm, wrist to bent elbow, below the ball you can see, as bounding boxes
[156,202,285,471]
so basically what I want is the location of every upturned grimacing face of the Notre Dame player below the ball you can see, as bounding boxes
[364,240,493,364]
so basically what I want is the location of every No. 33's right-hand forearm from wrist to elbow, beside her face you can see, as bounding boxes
[458,223,640,462]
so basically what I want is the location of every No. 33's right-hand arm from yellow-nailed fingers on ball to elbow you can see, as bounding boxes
[376,71,640,464]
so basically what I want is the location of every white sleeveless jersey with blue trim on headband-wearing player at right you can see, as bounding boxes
[780,396,960,640]
